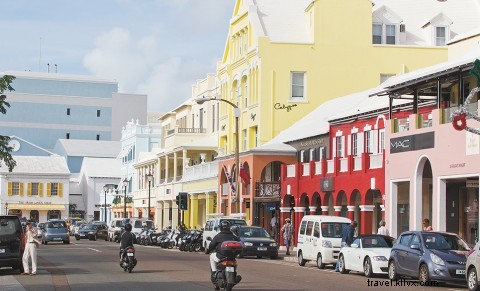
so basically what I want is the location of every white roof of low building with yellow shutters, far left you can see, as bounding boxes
[0,156,70,175]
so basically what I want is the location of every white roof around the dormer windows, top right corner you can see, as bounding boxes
[372,0,480,45]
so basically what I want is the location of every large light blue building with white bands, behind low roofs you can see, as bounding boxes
[0,71,147,150]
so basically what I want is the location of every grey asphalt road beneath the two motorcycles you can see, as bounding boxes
[0,240,467,291]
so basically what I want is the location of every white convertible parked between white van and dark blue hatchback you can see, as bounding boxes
[339,234,394,277]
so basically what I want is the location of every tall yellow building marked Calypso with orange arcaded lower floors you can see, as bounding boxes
[217,0,478,227]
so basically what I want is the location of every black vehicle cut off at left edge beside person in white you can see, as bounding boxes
[0,215,25,272]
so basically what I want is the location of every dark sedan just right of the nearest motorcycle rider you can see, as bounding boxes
[238,226,278,259]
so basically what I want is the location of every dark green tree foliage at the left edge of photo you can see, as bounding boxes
[0,75,17,172]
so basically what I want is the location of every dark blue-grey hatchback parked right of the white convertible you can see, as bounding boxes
[388,231,470,283]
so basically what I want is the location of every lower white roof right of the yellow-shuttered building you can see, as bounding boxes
[80,157,121,178]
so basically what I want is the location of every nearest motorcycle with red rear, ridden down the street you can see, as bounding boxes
[207,237,242,291]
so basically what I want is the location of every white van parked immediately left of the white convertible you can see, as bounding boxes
[297,215,351,269]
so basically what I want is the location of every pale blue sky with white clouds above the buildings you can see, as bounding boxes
[0,0,235,112]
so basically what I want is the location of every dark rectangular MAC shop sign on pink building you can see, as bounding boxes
[390,131,435,154]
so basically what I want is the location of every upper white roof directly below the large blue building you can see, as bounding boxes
[55,139,122,158]
